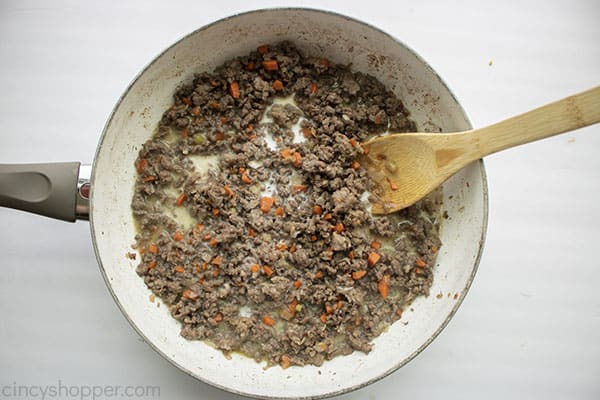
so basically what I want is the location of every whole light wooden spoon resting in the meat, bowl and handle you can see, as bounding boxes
[364,86,600,214]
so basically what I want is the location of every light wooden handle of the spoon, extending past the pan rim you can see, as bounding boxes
[471,86,600,159]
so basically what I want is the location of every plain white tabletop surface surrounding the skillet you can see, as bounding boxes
[0,0,600,400]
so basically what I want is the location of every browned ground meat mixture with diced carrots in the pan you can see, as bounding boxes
[132,42,440,368]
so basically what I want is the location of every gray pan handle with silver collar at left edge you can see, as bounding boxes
[0,162,91,222]
